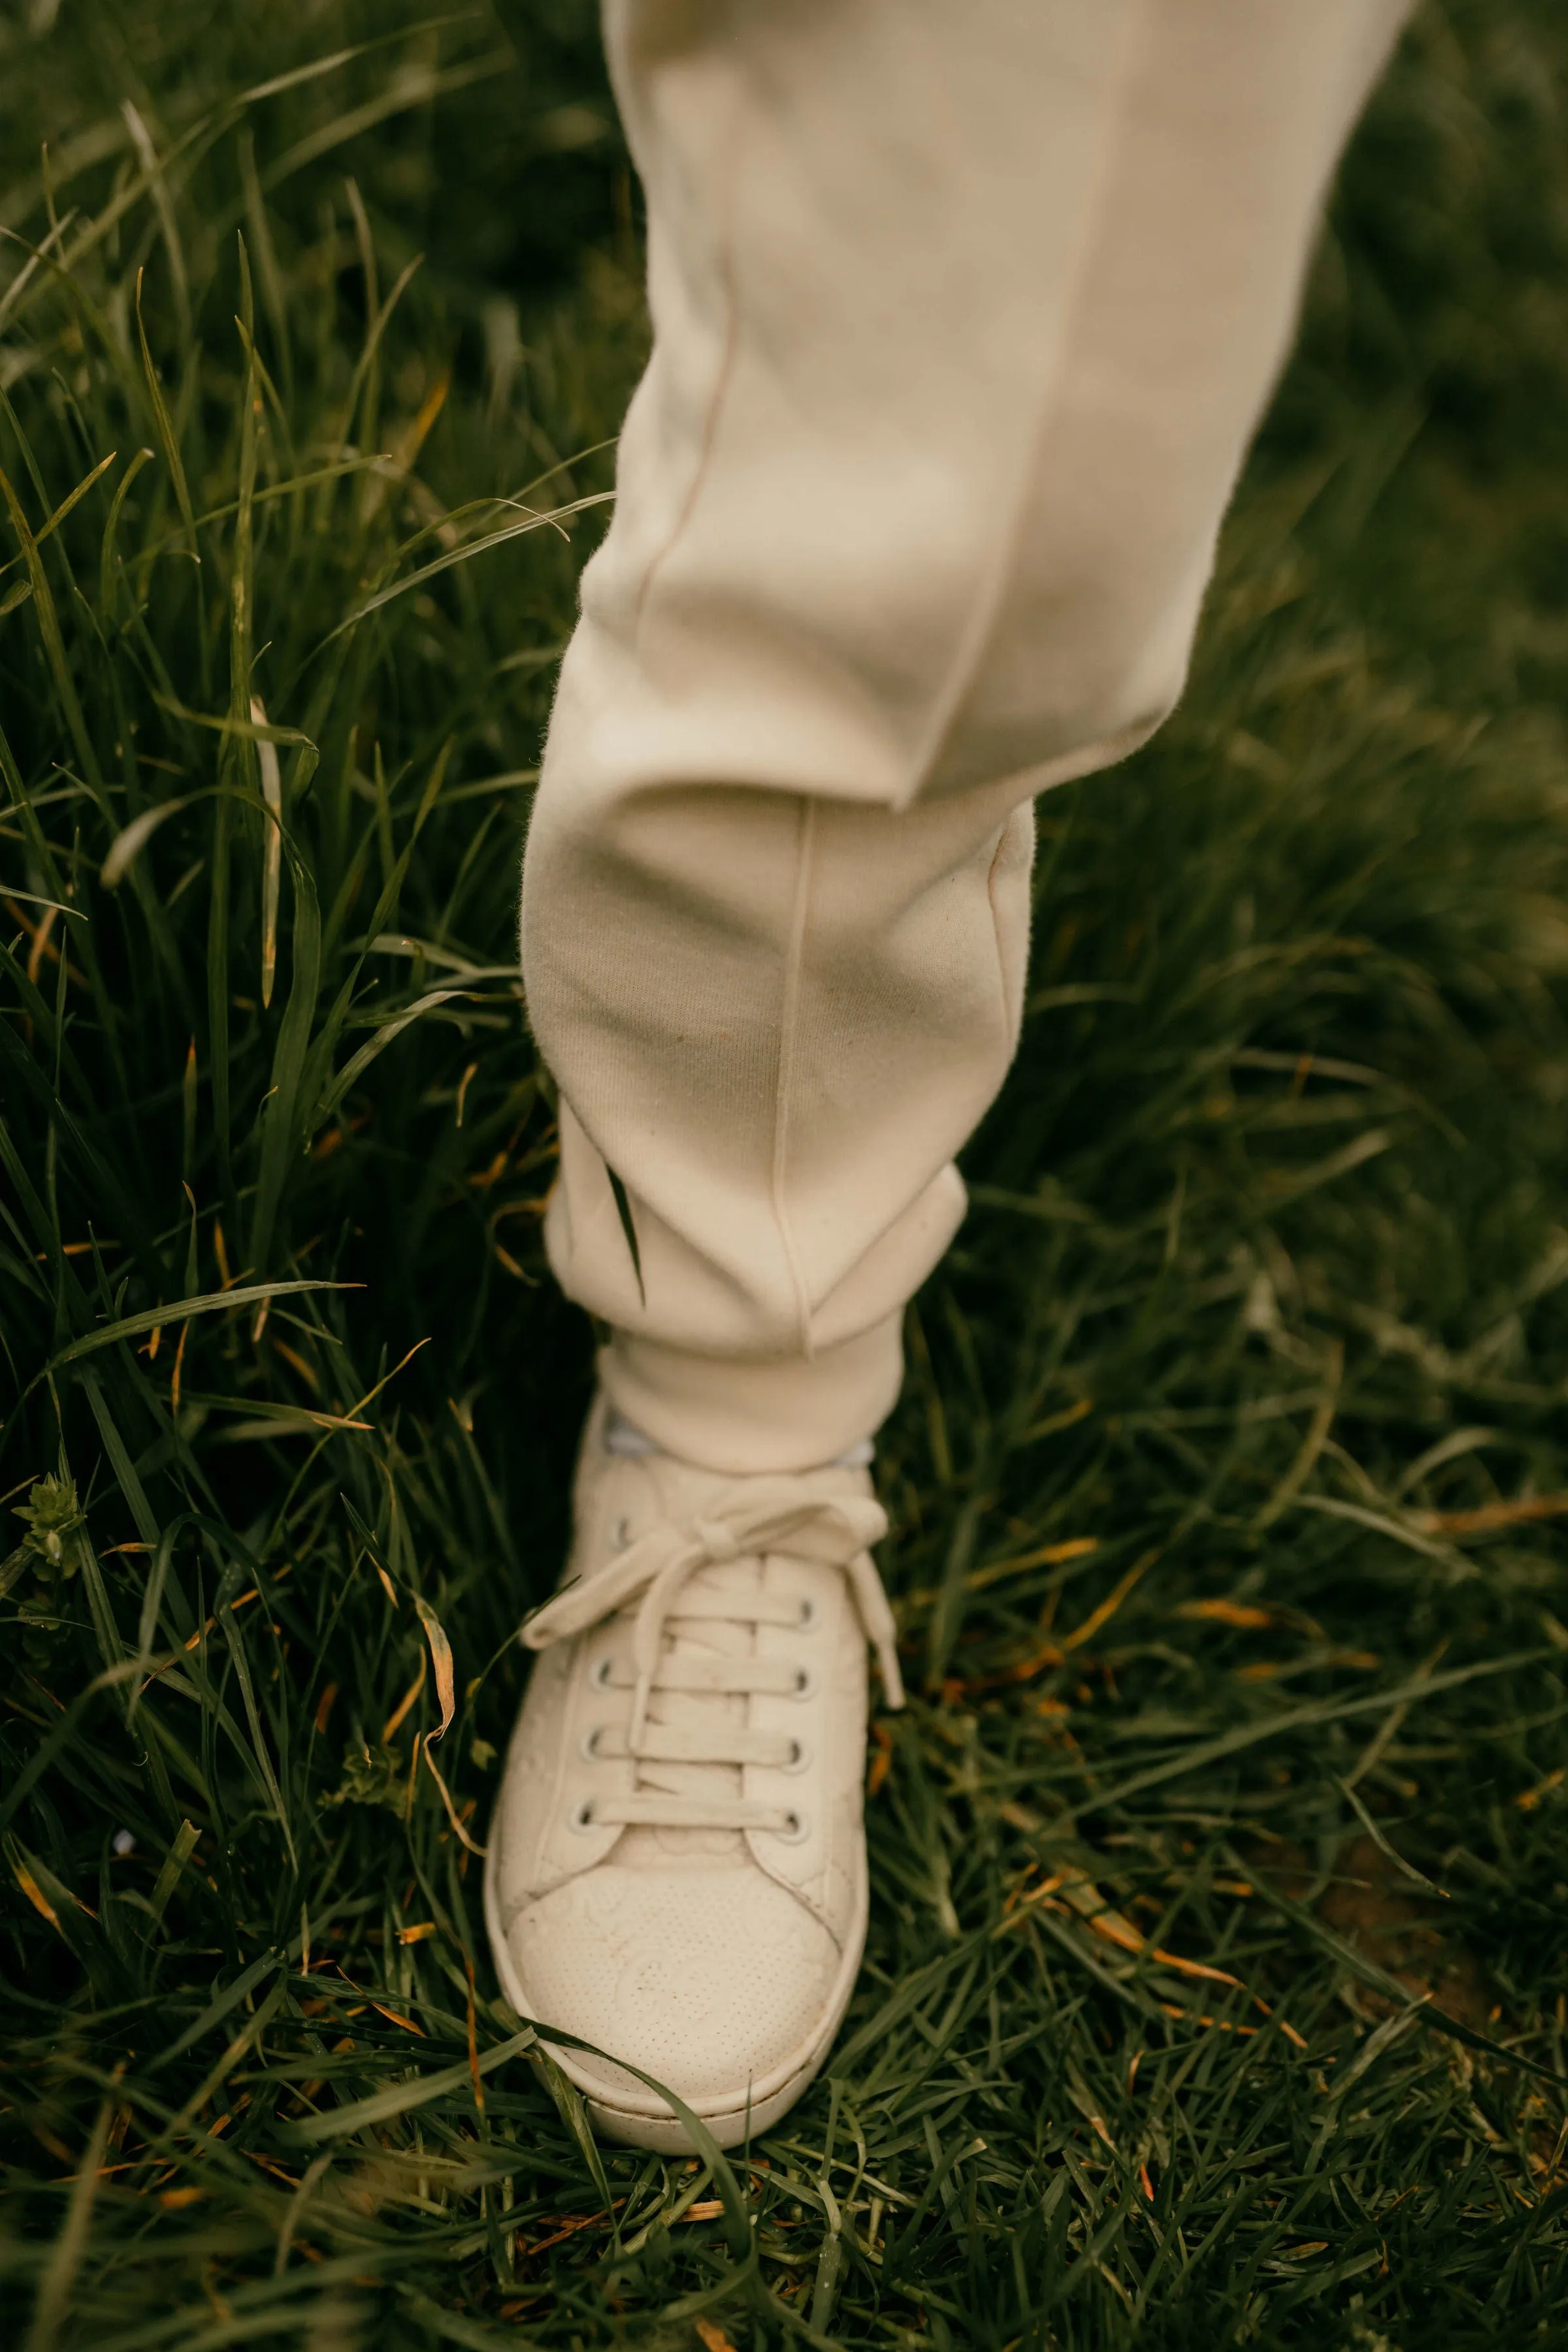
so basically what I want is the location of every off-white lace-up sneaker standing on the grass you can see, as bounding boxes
[484,1399,903,2152]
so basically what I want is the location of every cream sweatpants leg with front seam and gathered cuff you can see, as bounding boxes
[522,0,1403,1470]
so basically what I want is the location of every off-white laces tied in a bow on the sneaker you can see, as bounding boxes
[522,1477,903,1837]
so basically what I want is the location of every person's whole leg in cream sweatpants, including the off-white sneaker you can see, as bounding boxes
[487,0,1401,2148]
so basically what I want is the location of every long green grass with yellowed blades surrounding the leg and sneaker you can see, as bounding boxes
[0,0,1568,2352]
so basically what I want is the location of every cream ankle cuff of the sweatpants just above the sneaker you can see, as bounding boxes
[600,1313,903,1475]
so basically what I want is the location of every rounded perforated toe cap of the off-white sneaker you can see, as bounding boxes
[508,1863,841,2112]
